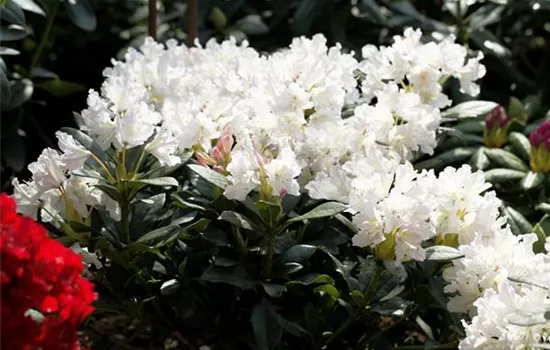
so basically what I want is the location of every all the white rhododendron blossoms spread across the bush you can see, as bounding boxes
[13,29,550,349]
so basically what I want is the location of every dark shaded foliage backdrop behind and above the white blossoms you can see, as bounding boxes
[0,0,550,192]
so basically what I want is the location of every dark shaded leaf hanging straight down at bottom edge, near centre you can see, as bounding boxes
[250,300,283,350]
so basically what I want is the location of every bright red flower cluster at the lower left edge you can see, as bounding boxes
[0,194,96,350]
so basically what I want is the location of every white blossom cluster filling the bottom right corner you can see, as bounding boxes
[443,223,550,350]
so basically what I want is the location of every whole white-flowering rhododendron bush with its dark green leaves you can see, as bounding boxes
[9,29,550,349]
